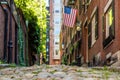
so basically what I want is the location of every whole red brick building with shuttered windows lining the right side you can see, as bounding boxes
[61,0,120,66]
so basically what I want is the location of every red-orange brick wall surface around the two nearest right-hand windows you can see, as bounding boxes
[80,0,120,65]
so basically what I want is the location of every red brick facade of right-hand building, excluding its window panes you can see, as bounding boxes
[61,0,120,65]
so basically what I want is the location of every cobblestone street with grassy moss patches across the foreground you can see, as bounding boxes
[0,65,120,80]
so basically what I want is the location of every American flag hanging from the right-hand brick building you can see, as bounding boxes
[63,6,77,27]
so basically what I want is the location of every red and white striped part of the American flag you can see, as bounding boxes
[63,6,77,27]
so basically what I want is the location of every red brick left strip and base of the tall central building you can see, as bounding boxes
[49,0,61,65]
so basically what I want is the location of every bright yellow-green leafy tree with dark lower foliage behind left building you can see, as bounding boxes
[15,0,48,59]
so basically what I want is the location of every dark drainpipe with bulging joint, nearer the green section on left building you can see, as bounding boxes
[7,0,13,63]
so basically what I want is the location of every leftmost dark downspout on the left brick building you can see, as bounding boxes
[3,8,8,61]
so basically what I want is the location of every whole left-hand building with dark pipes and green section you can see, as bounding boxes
[0,0,28,65]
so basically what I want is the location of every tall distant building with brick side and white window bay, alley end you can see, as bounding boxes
[49,0,62,65]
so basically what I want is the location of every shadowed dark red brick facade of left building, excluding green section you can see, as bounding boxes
[0,1,28,64]
